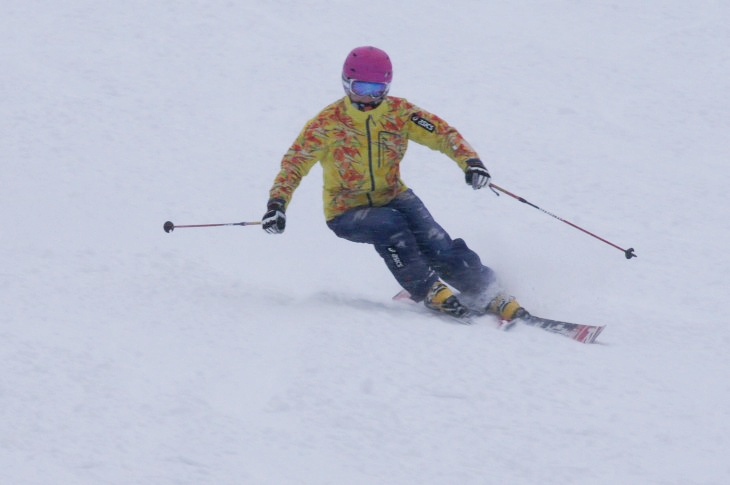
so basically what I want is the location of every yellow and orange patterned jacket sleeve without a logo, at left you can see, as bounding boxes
[269,118,325,207]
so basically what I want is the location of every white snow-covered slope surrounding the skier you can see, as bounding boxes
[0,0,730,485]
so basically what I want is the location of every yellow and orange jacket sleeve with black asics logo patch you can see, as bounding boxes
[403,103,479,170]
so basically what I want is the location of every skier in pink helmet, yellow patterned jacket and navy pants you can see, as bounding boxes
[262,46,521,320]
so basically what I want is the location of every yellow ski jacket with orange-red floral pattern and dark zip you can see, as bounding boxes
[269,96,479,220]
